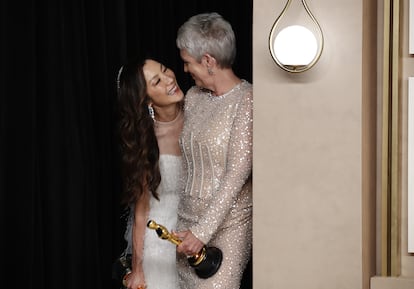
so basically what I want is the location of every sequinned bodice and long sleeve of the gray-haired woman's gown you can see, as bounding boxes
[178,81,253,243]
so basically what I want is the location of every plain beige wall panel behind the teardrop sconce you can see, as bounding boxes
[253,0,414,289]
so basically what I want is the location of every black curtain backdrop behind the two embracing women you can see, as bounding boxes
[0,0,252,289]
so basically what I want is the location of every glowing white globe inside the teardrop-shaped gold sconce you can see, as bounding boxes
[273,25,318,66]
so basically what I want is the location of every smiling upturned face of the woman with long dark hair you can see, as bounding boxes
[143,59,184,109]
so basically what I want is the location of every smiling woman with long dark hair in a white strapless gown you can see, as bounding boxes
[118,59,184,289]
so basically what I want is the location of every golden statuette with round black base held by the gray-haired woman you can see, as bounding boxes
[147,220,223,279]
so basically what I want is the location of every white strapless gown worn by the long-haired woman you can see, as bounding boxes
[125,155,182,289]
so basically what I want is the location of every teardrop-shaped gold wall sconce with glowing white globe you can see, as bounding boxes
[269,0,324,73]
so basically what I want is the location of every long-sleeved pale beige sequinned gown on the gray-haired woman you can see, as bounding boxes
[177,80,253,289]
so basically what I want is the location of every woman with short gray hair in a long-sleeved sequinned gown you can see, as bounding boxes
[174,13,253,289]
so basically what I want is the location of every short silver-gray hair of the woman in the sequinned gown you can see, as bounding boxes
[176,12,236,68]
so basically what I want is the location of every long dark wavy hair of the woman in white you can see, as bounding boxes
[117,59,161,205]
